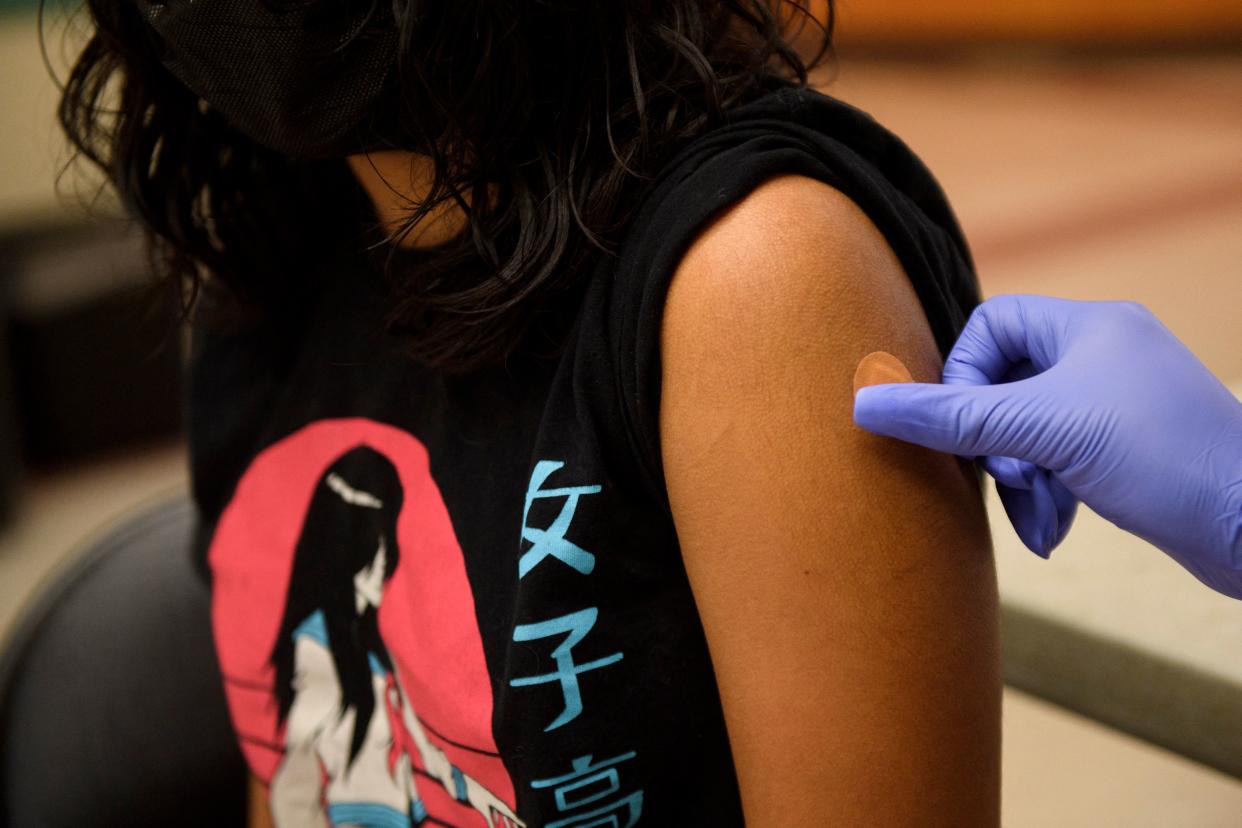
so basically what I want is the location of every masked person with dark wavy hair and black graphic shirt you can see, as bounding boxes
[61,0,1000,828]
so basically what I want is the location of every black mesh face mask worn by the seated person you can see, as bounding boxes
[135,0,397,158]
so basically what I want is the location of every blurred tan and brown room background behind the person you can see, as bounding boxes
[0,0,1242,826]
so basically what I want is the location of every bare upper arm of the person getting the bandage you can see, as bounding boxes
[660,176,1001,828]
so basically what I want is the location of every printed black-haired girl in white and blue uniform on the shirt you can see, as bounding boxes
[270,446,523,828]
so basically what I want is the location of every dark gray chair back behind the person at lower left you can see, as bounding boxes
[0,495,246,828]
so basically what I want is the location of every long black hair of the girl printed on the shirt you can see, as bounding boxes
[271,446,402,763]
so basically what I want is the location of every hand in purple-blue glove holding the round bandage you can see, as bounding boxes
[854,295,1242,598]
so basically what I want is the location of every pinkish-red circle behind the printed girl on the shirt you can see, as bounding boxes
[209,417,514,824]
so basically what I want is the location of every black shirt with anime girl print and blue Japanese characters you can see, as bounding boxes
[189,88,979,828]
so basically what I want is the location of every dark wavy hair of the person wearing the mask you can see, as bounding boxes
[48,0,832,370]
